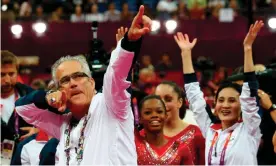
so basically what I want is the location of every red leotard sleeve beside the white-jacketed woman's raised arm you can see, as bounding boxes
[194,127,205,165]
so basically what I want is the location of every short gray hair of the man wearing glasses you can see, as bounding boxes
[52,55,92,87]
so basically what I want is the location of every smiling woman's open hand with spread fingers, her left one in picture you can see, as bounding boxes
[174,32,197,51]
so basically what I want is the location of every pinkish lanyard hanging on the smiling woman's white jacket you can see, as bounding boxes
[208,131,233,165]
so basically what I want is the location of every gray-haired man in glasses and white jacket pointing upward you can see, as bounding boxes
[16,6,151,165]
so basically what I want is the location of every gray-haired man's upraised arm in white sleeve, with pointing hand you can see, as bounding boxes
[103,6,151,120]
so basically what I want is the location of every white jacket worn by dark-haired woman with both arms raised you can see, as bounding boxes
[185,82,262,165]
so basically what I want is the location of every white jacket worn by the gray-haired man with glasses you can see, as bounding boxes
[16,39,137,165]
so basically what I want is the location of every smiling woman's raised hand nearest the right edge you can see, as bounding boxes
[243,21,264,48]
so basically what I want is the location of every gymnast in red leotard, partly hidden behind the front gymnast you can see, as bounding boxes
[155,81,205,165]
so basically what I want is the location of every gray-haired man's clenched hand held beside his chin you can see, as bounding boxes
[46,90,67,112]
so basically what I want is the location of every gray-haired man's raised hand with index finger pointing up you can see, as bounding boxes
[128,5,151,41]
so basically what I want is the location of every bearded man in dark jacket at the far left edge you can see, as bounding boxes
[0,50,37,162]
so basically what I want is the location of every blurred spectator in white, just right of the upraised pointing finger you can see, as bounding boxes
[156,0,177,20]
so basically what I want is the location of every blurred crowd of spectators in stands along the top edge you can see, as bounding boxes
[1,0,276,22]
